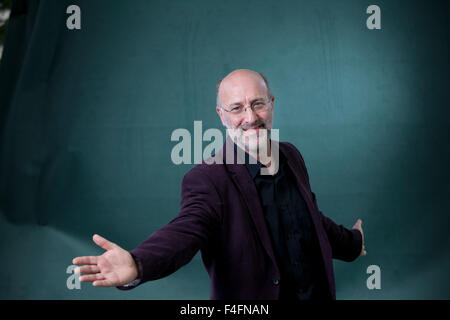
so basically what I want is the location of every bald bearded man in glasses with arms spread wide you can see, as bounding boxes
[73,70,366,300]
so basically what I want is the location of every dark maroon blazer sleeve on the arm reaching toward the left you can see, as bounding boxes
[123,166,222,284]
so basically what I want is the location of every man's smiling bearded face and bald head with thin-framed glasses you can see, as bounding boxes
[216,69,275,152]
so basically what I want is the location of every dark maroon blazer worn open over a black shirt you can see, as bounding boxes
[124,139,362,300]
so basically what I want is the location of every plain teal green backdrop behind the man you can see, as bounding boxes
[0,0,450,299]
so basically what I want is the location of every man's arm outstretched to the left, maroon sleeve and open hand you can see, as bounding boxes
[73,168,221,289]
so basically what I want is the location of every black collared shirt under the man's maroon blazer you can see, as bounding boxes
[239,144,329,300]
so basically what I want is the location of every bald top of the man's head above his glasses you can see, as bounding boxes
[216,69,272,107]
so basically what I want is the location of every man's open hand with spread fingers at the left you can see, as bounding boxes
[72,234,138,287]
